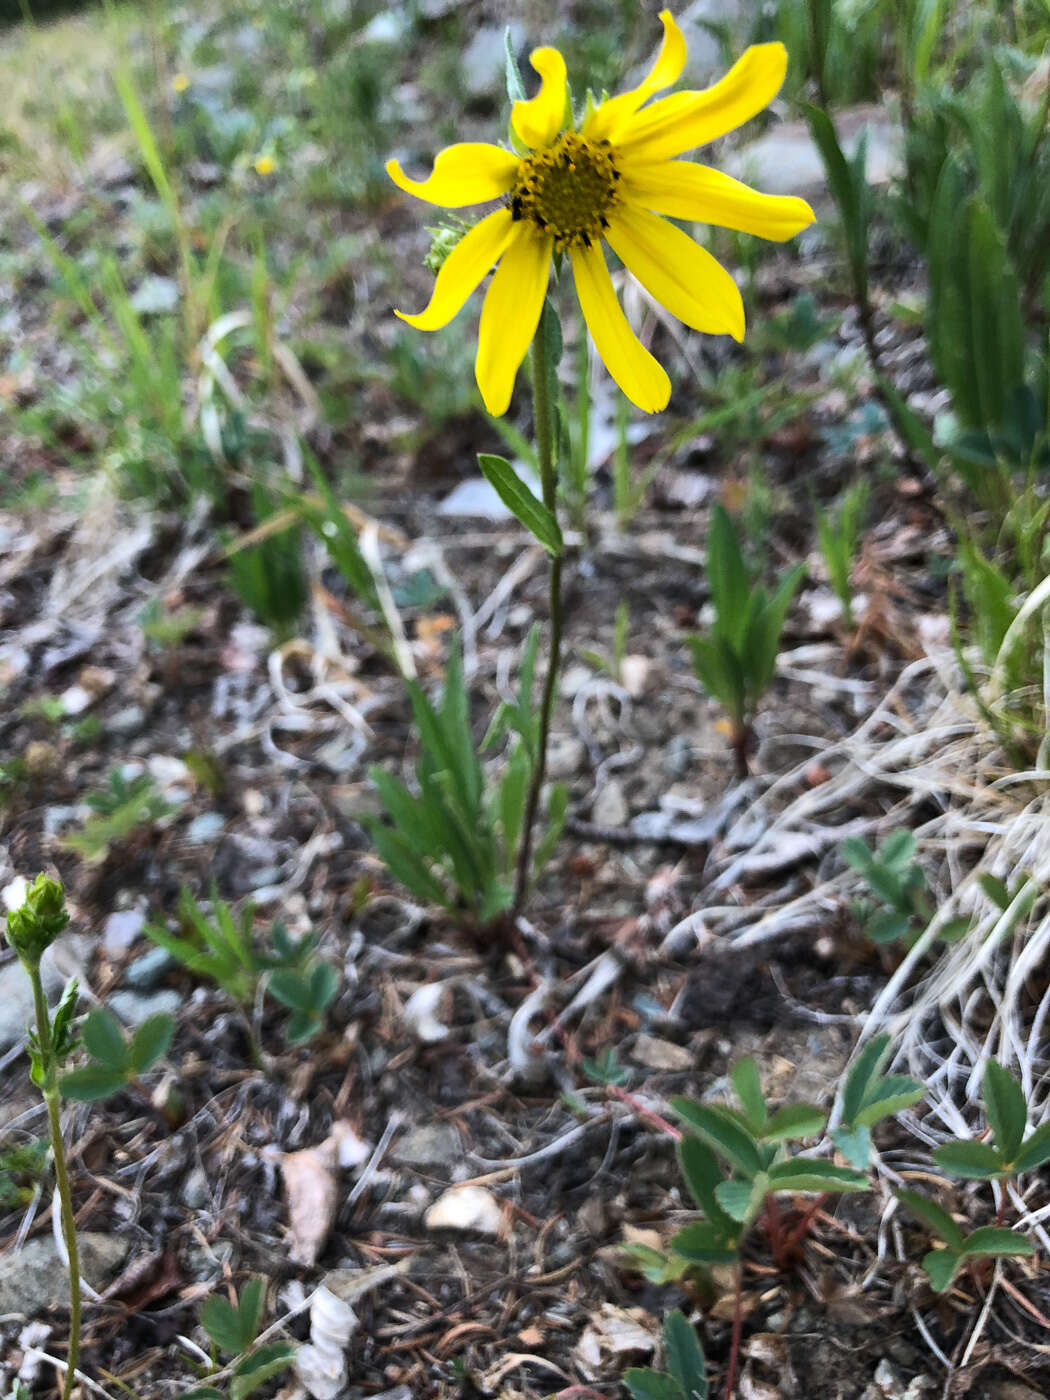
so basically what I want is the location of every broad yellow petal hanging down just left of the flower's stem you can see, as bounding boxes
[475,224,554,417]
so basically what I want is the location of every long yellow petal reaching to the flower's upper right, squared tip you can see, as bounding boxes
[617,43,787,161]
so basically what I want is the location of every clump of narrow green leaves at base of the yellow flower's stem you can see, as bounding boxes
[370,638,567,925]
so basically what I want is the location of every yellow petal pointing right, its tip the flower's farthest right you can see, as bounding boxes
[620,161,815,242]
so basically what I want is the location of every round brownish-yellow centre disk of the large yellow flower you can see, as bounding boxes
[510,132,620,252]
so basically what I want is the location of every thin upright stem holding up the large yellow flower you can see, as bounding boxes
[514,304,563,914]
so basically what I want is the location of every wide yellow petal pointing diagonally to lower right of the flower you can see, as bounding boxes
[605,207,743,340]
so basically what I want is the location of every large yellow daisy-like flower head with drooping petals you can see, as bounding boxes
[386,10,813,414]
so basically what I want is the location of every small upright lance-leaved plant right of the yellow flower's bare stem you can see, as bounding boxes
[686,505,805,777]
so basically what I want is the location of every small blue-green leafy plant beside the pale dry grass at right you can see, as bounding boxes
[840,829,970,946]
